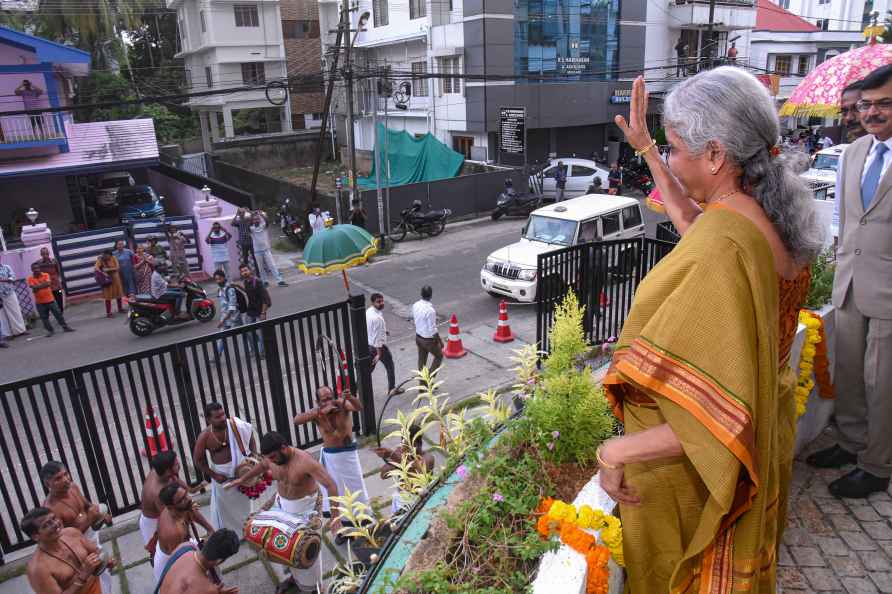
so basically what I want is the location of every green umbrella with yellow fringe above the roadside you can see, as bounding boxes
[300,225,378,295]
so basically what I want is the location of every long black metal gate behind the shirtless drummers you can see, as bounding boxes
[0,295,375,562]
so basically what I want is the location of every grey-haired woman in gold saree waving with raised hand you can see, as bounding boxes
[598,67,821,594]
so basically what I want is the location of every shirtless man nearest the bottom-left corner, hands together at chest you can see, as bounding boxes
[20,507,115,594]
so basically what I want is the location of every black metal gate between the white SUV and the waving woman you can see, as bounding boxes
[536,237,675,352]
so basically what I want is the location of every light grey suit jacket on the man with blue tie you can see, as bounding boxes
[833,135,892,319]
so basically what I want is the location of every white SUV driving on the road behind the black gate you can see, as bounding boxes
[480,194,644,302]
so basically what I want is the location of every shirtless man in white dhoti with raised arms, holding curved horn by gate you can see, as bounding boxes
[294,386,369,514]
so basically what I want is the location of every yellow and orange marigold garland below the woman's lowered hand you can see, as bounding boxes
[536,497,625,594]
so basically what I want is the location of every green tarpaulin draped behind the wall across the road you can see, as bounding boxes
[357,124,465,190]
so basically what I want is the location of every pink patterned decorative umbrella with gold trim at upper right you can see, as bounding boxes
[780,36,892,117]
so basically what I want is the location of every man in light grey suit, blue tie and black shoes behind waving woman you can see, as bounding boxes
[807,65,892,499]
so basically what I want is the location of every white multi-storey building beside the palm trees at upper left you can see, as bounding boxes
[167,0,291,150]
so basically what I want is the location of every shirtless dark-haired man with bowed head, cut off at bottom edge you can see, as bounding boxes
[154,528,239,594]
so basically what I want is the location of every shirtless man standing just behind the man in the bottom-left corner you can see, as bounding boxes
[38,460,112,594]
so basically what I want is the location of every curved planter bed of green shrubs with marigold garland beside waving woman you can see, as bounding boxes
[338,297,622,594]
